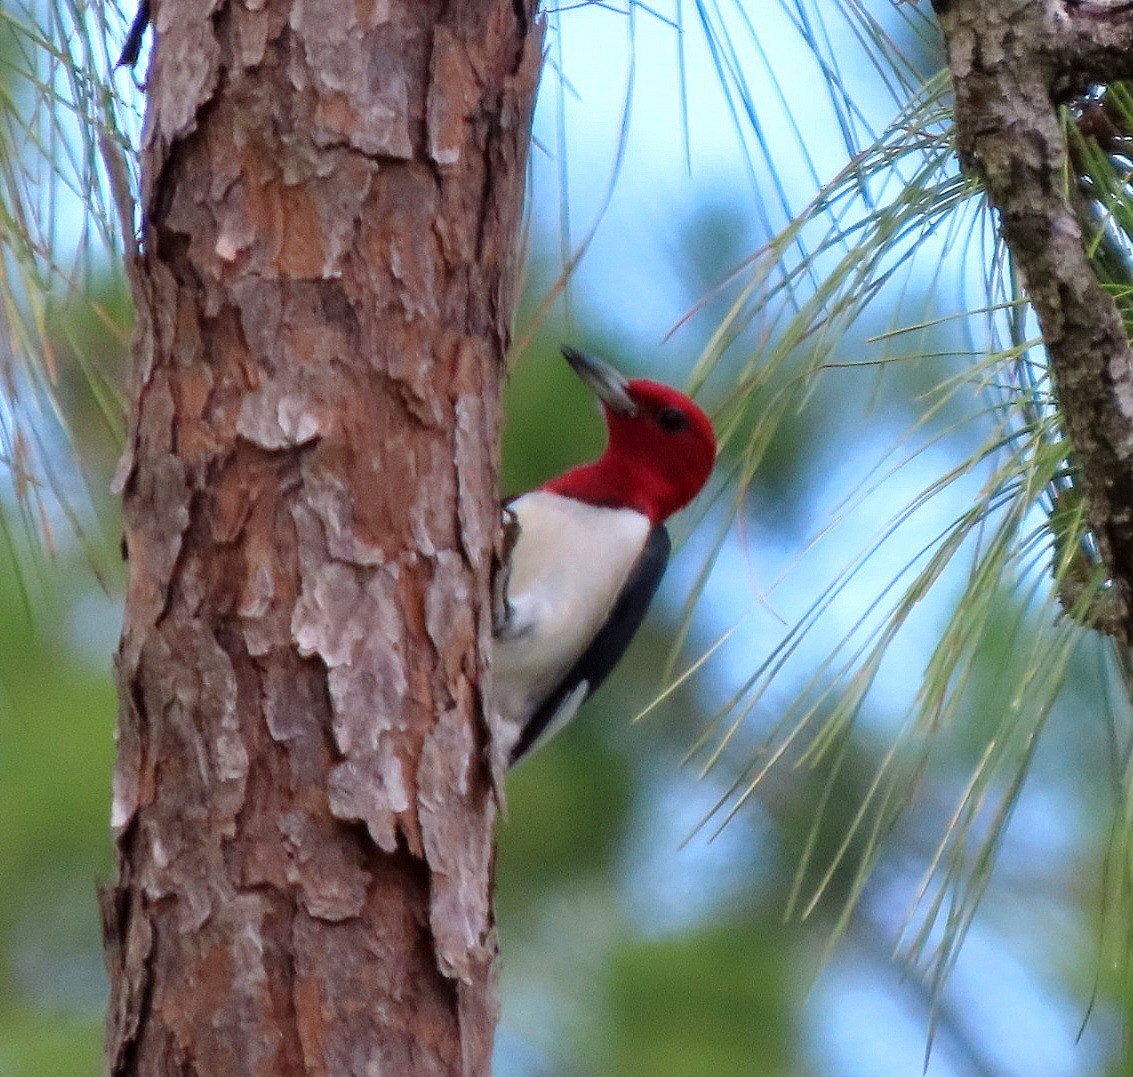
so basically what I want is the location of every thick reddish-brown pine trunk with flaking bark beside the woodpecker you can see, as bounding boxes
[104,0,540,1077]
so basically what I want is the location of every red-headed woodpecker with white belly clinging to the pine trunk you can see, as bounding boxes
[492,348,716,762]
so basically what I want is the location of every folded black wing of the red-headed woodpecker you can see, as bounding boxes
[511,524,673,763]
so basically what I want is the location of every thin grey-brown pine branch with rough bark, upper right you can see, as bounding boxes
[934,0,1133,641]
